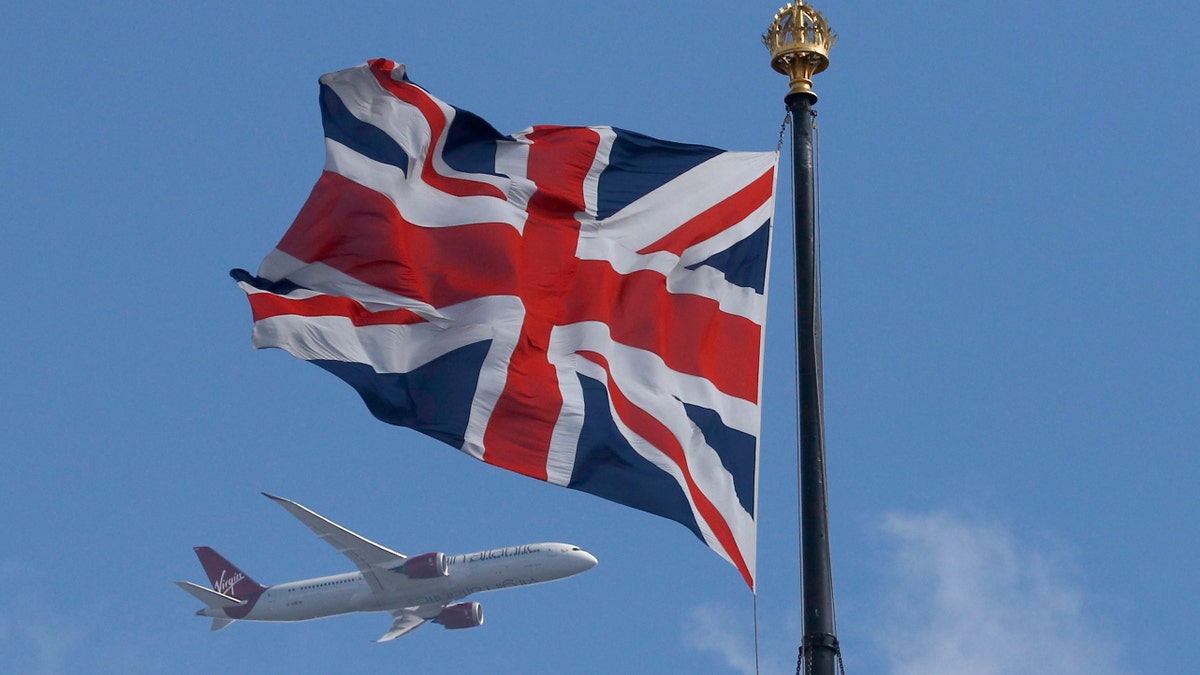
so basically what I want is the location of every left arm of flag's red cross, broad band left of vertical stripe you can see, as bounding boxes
[278,172,521,307]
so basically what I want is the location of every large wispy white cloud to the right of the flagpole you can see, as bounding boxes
[875,514,1123,675]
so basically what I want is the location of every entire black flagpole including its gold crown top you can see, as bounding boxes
[763,1,841,675]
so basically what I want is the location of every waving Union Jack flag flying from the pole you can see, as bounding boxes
[232,60,778,589]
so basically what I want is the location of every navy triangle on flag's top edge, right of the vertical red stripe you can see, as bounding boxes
[596,129,724,220]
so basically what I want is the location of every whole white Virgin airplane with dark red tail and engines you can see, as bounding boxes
[175,492,596,643]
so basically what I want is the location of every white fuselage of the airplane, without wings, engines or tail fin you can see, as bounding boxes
[197,543,596,621]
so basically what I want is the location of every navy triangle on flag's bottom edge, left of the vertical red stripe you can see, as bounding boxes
[312,340,492,448]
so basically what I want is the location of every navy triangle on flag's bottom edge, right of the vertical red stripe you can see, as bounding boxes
[566,375,704,539]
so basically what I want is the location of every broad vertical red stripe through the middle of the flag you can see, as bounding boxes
[484,127,600,480]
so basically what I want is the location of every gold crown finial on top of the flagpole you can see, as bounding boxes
[762,0,838,98]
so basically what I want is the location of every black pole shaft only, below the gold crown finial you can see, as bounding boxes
[785,92,839,675]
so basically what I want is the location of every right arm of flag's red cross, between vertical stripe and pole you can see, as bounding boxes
[564,261,762,402]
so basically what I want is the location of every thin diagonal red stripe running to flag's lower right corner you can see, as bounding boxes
[578,351,754,591]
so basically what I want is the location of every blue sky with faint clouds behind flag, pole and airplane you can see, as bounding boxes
[0,0,1200,675]
